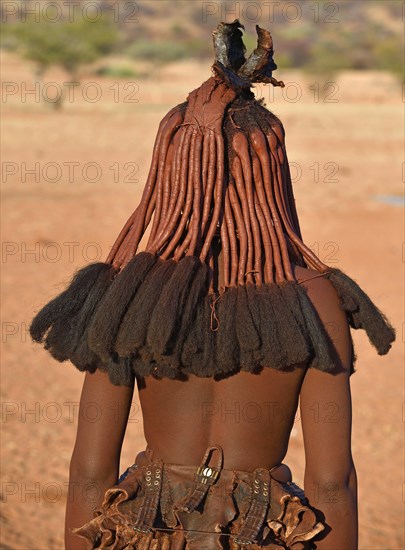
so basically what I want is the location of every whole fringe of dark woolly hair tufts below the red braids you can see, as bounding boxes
[31,258,395,385]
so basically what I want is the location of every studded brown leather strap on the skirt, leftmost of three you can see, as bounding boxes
[133,459,163,533]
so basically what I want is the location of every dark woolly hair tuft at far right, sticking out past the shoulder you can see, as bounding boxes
[326,268,396,355]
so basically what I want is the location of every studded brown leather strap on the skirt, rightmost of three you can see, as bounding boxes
[234,468,271,545]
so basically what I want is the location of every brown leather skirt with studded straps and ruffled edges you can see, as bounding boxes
[72,445,325,550]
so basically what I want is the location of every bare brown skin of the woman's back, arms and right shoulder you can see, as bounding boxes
[65,260,358,550]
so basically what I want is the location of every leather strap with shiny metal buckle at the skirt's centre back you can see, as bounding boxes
[175,445,223,513]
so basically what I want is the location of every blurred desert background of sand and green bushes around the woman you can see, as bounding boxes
[0,0,405,550]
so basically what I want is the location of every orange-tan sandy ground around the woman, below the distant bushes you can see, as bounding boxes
[1,54,405,550]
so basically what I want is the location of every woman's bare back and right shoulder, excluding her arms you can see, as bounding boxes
[138,266,351,470]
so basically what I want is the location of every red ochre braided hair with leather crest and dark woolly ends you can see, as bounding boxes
[30,20,395,384]
